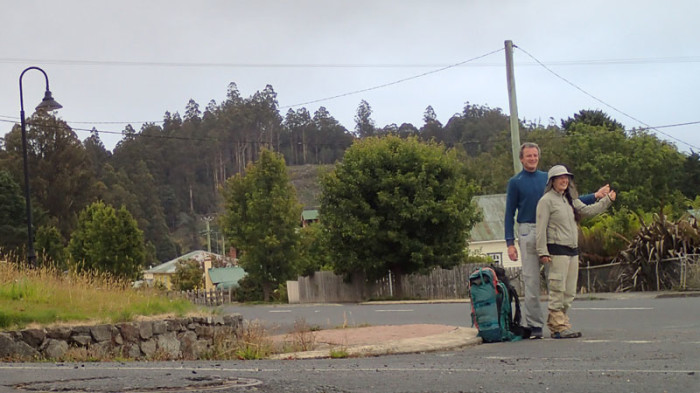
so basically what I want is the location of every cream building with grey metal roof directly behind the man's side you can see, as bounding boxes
[469,194,521,267]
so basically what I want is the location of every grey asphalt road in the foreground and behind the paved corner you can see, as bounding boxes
[0,298,700,393]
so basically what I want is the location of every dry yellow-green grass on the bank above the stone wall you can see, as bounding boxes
[0,261,197,330]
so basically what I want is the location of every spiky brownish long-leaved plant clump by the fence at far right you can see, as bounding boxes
[617,214,700,291]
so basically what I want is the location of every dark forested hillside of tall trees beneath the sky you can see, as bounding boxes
[0,83,700,272]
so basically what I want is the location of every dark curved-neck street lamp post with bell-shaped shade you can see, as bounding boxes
[19,67,62,266]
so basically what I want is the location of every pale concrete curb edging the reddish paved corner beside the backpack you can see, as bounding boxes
[270,327,481,360]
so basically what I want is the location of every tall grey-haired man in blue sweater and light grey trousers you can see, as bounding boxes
[505,142,610,338]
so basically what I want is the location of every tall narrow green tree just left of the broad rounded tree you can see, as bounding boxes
[221,149,301,301]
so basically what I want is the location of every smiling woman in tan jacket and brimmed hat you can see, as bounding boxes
[535,165,616,338]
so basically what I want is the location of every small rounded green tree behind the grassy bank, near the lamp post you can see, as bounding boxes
[68,201,146,279]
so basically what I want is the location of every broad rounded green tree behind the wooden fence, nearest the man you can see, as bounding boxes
[320,136,479,290]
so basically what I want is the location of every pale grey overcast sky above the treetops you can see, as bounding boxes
[0,0,700,151]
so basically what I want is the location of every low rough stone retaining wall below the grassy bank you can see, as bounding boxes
[0,314,243,360]
